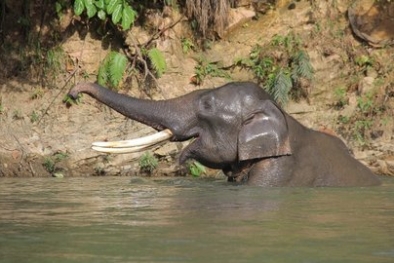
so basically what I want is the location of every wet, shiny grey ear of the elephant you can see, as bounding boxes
[238,100,291,161]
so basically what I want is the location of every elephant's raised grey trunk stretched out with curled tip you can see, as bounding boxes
[69,83,202,140]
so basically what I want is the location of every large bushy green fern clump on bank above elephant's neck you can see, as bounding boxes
[235,34,314,105]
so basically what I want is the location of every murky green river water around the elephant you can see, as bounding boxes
[0,177,394,263]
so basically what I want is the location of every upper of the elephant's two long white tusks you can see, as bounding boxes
[92,129,172,148]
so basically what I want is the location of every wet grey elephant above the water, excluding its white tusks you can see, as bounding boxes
[69,82,380,186]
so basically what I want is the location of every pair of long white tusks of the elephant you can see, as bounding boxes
[92,129,174,153]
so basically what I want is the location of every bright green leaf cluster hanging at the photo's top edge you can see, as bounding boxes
[74,0,137,30]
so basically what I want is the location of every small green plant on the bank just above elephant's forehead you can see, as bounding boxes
[193,57,231,85]
